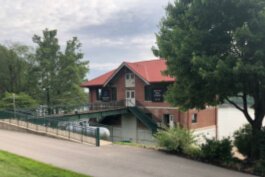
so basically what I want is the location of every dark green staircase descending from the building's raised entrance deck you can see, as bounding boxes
[128,106,158,133]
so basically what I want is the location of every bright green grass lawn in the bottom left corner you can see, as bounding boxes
[0,151,88,177]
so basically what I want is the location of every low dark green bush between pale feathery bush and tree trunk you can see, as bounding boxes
[201,138,233,164]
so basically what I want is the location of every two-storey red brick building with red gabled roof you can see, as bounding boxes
[81,59,217,143]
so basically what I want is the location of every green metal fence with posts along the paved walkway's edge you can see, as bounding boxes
[0,110,107,146]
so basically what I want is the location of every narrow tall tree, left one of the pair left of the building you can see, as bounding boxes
[33,29,60,107]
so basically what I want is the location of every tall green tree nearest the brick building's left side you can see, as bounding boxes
[54,37,88,105]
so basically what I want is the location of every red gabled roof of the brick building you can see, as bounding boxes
[81,59,175,87]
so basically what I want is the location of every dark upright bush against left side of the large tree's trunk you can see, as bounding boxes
[234,124,252,157]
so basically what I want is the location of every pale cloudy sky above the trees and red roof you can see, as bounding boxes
[0,0,169,79]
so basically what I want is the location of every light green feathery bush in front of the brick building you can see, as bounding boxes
[155,125,195,153]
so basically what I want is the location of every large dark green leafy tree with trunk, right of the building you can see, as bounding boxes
[154,0,265,160]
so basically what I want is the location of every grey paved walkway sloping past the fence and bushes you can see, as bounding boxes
[0,130,254,177]
